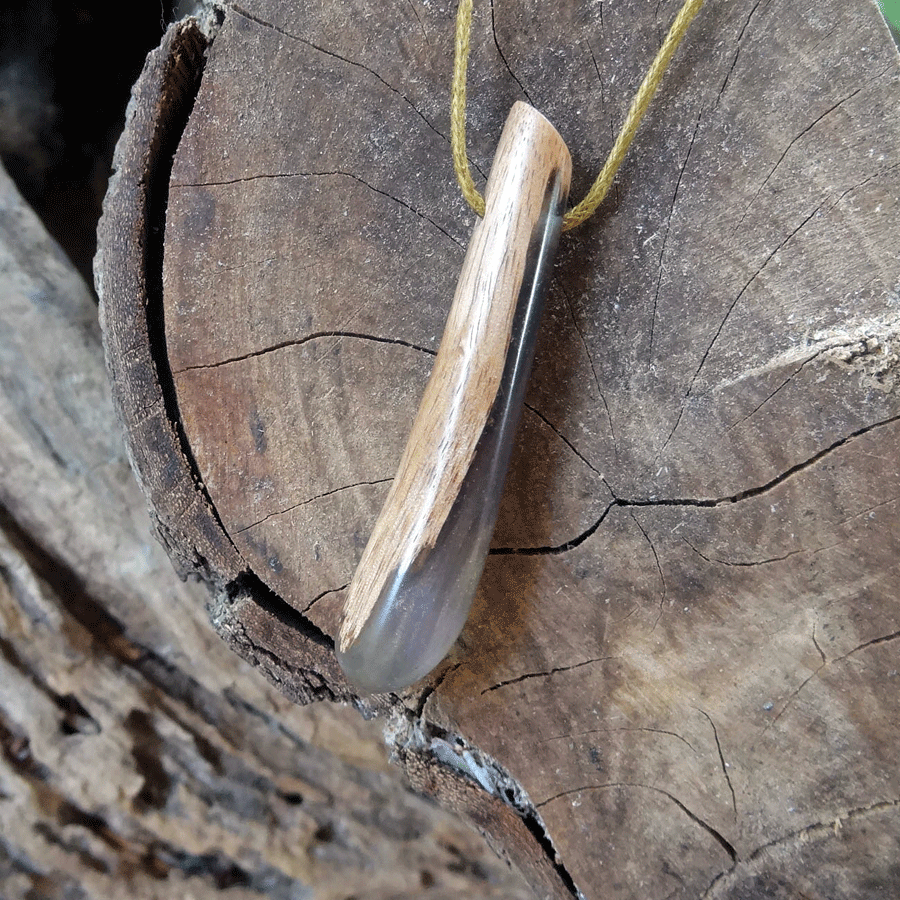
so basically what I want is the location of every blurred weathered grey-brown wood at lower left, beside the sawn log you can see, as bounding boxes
[0,153,528,900]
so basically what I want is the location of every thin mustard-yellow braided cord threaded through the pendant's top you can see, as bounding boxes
[450,0,703,231]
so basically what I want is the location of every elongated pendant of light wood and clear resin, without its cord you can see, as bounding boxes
[338,102,572,693]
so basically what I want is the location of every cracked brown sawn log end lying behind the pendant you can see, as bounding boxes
[101,0,900,900]
